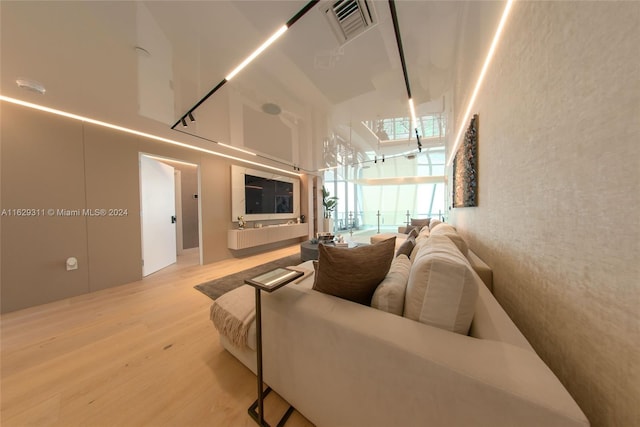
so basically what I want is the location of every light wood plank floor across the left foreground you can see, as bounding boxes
[0,245,311,427]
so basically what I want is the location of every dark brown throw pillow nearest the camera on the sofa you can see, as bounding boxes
[313,237,396,305]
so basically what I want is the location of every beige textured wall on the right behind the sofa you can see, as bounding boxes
[451,2,640,426]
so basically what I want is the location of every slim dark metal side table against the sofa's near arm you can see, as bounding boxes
[244,268,303,427]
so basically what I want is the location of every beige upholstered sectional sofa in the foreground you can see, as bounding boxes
[211,222,589,427]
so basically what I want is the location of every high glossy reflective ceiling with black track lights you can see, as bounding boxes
[0,0,496,170]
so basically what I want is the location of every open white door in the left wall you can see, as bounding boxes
[140,156,176,276]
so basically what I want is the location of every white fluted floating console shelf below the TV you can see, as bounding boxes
[227,223,309,249]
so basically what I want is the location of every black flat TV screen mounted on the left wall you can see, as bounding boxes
[244,174,293,214]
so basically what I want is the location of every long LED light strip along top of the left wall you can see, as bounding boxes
[0,95,301,177]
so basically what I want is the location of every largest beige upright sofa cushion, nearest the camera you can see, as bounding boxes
[403,236,479,335]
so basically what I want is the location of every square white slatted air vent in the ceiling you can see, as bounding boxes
[325,0,377,45]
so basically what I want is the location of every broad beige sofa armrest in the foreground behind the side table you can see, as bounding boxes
[262,287,588,426]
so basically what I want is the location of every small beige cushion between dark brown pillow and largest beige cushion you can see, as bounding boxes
[371,255,411,316]
